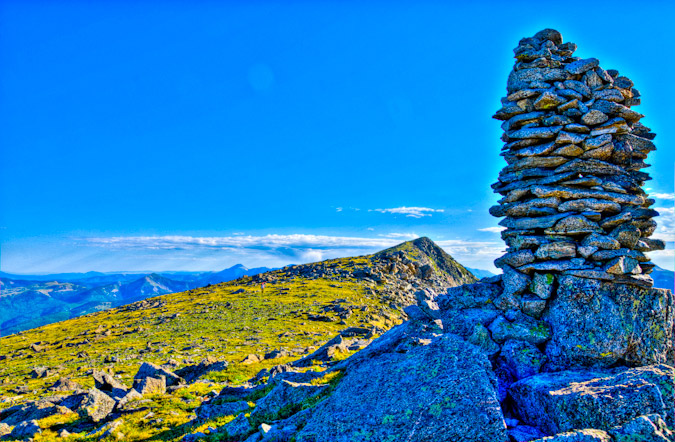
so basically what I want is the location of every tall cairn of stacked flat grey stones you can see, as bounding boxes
[490,29,665,309]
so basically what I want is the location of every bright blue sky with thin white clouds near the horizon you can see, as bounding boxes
[0,0,675,273]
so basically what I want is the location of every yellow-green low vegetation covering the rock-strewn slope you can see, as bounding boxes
[0,257,400,441]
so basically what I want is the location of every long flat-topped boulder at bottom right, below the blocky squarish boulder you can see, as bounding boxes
[509,364,675,434]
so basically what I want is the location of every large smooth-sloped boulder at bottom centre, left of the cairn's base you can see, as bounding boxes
[296,334,508,442]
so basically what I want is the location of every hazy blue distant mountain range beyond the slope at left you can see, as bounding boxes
[0,264,270,336]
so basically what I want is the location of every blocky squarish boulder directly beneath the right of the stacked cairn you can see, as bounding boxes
[542,276,675,371]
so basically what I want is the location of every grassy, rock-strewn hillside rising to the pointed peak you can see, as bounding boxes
[0,238,476,441]
